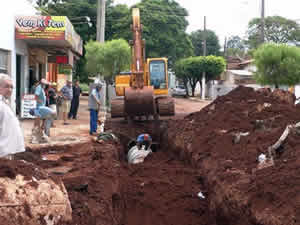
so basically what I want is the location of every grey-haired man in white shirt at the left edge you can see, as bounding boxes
[0,73,25,158]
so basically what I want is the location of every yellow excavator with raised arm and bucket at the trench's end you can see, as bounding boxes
[111,8,175,120]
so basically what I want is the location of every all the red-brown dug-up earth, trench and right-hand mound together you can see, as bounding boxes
[8,88,300,225]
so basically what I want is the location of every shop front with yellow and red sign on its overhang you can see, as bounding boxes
[15,15,82,114]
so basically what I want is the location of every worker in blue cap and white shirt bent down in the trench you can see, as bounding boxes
[127,134,152,164]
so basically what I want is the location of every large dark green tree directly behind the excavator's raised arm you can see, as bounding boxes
[134,0,193,65]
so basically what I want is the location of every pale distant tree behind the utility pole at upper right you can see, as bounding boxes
[247,16,300,48]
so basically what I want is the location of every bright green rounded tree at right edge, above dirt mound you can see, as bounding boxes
[254,44,300,88]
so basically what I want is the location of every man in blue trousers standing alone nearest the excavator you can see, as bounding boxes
[88,83,102,135]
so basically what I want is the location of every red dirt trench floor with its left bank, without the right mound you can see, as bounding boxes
[23,121,215,225]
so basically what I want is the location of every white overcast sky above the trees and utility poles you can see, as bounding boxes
[115,0,300,45]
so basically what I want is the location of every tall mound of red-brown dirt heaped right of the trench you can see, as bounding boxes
[165,87,300,225]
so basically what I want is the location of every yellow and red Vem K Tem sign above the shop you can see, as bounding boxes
[15,16,67,40]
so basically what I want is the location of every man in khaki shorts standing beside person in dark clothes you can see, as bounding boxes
[60,80,73,125]
